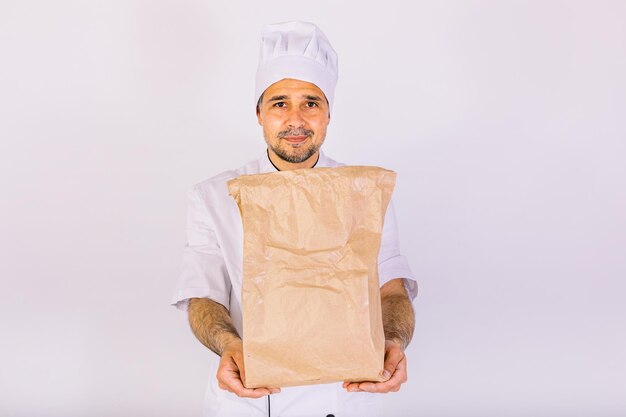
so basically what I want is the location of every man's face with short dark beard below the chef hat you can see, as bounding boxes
[257,78,330,164]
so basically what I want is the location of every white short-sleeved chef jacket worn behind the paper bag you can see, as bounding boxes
[172,151,417,417]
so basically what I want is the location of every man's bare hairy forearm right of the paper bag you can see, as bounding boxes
[381,294,415,349]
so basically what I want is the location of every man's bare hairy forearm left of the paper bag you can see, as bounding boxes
[188,298,241,356]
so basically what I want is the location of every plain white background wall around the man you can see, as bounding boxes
[0,0,626,417]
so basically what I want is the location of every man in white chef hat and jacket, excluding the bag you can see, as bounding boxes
[173,22,417,417]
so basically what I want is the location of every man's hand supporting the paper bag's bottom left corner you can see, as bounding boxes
[217,339,280,398]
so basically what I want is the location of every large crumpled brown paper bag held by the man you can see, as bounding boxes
[228,167,396,388]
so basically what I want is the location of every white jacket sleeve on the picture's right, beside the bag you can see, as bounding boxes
[378,201,417,300]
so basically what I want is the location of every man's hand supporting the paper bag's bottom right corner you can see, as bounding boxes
[343,341,407,393]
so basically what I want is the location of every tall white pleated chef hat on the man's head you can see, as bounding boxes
[255,22,337,108]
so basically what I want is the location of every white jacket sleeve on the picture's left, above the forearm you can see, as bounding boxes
[171,187,231,311]
